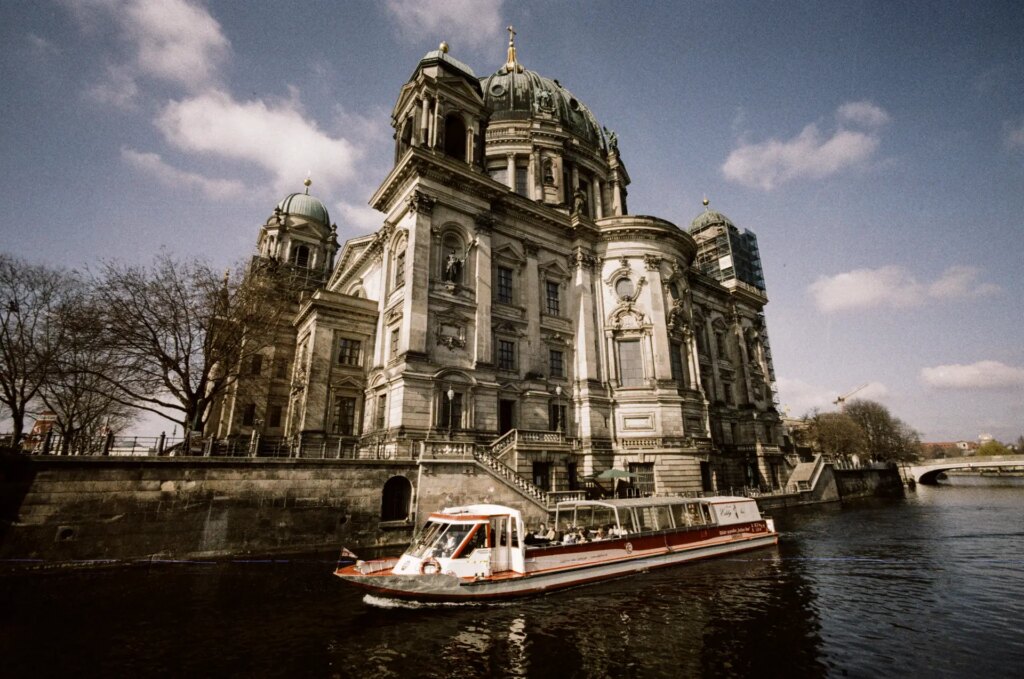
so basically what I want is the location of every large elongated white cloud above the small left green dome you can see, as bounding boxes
[156,91,362,193]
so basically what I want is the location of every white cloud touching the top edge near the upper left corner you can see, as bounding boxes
[69,0,230,99]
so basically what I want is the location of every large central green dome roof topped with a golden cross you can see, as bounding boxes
[480,36,606,148]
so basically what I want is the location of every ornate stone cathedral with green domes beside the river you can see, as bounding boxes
[208,31,787,494]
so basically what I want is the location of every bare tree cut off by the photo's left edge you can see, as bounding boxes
[0,253,80,448]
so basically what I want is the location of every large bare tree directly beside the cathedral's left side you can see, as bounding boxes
[96,253,285,431]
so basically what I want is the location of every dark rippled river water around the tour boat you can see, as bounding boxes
[0,484,1024,678]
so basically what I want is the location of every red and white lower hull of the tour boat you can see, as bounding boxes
[335,533,778,602]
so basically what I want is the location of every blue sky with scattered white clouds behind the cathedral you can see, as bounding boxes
[0,0,1024,440]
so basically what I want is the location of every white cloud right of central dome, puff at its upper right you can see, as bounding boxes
[722,101,889,190]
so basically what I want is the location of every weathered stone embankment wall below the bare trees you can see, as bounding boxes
[0,456,419,565]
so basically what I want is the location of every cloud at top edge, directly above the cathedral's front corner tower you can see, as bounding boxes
[386,0,504,52]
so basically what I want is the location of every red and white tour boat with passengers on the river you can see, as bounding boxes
[335,497,778,602]
